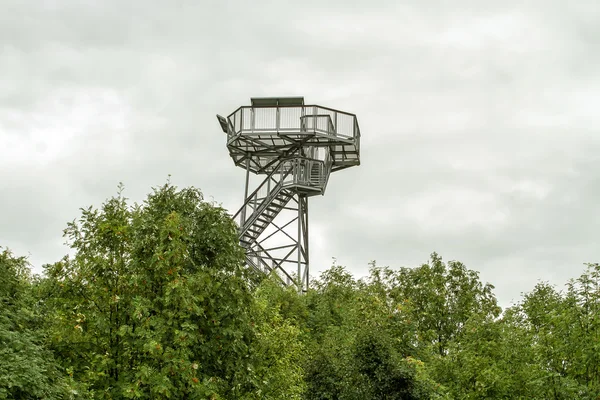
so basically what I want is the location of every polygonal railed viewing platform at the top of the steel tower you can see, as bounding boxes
[217,97,360,174]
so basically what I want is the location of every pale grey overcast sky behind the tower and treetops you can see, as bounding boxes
[0,0,600,305]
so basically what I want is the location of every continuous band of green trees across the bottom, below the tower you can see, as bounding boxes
[0,184,600,400]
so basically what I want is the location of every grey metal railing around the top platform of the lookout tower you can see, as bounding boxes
[227,105,360,140]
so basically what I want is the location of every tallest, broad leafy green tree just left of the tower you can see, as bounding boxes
[45,184,253,399]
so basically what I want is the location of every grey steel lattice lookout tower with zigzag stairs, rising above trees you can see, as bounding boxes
[217,97,360,291]
